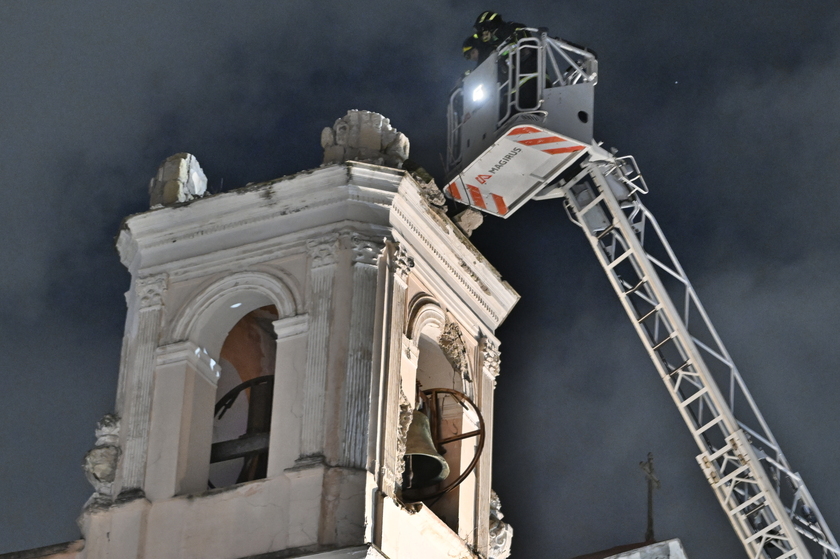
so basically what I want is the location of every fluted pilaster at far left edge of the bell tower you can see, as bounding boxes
[120,274,167,493]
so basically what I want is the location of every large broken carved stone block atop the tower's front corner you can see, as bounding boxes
[321,110,409,169]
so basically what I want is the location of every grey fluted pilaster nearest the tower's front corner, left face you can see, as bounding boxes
[339,234,382,469]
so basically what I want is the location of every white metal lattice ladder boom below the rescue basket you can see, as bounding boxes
[561,157,840,559]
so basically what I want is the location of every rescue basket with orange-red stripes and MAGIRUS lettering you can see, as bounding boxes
[445,29,597,217]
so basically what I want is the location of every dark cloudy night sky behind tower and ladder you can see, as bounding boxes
[0,0,840,559]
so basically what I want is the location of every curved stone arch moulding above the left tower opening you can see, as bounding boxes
[168,271,301,359]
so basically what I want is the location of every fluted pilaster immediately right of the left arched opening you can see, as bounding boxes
[300,235,338,457]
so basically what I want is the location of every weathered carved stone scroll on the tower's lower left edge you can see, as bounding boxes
[82,413,121,507]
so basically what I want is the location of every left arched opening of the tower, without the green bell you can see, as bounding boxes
[209,305,279,487]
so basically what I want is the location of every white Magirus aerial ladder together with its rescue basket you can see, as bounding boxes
[444,29,840,559]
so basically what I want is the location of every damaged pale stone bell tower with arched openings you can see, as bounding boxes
[76,111,518,559]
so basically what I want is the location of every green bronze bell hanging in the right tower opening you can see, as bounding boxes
[403,410,449,490]
